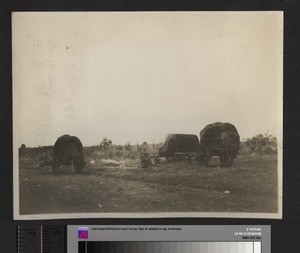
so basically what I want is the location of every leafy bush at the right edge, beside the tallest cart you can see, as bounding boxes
[240,133,277,155]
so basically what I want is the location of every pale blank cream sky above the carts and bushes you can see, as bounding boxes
[12,12,283,147]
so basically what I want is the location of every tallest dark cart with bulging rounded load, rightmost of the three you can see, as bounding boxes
[198,122,240,167]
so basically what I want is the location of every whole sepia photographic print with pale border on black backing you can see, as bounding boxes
[12,11,284,220]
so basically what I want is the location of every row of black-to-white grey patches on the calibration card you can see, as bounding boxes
[78,241,261,253]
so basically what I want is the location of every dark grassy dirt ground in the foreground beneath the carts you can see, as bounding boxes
[20,156,278,215]
